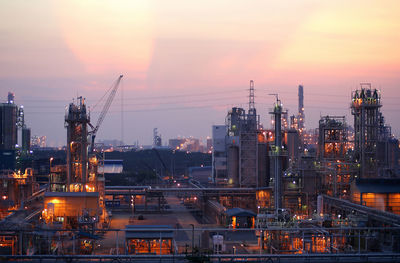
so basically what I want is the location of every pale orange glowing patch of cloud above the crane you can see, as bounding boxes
[54,0,153,78]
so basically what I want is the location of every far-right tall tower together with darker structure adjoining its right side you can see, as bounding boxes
[351,83,399,178]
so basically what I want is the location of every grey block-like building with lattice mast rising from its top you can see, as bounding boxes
[213,81,269,188]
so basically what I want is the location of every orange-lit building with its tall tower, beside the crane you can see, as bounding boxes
[42,97,106,233]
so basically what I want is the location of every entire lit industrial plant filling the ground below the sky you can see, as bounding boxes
[0,79,400,262]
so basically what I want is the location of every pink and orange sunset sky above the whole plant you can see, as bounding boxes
[0,0,400,146]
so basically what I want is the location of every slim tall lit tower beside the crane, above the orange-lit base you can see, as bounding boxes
[65,97,90,192]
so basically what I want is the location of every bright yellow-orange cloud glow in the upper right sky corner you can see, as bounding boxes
[275,1,400,74]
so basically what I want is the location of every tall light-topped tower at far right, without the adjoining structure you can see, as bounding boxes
[351,83,382,178]
